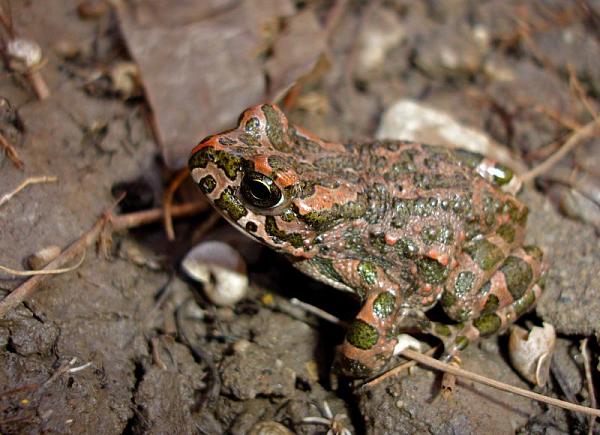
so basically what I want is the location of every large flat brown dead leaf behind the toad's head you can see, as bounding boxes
[118,0,294,168]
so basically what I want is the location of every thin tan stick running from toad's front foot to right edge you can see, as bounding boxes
[400,349,600,417]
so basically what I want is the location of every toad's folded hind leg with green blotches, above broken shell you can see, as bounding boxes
[441,246,544,362]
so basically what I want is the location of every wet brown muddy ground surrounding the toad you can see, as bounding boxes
[0,0,600,434]
